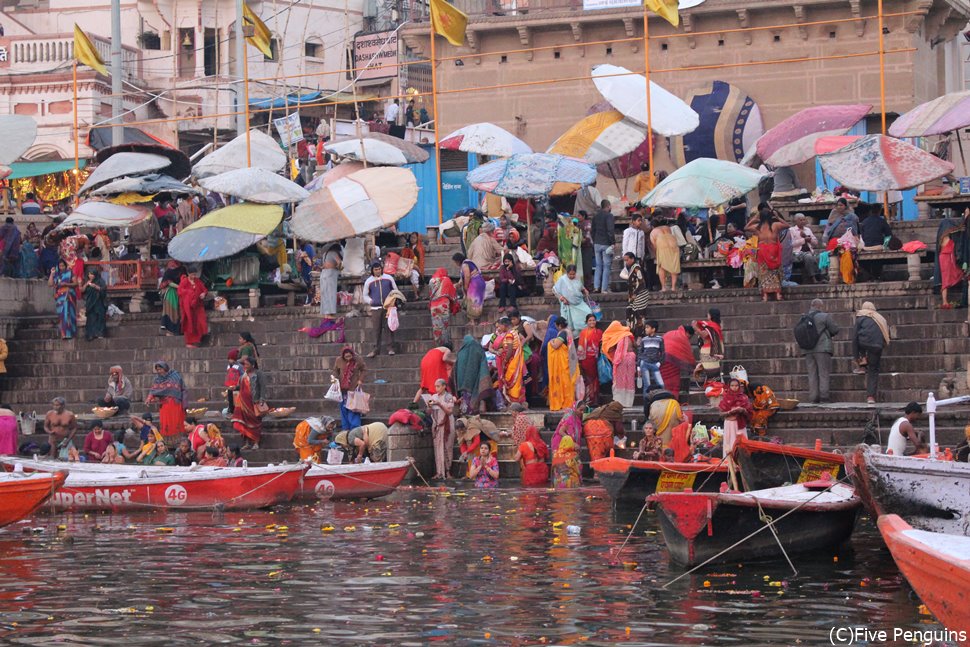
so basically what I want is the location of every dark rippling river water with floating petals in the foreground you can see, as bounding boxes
[0,487,939,646]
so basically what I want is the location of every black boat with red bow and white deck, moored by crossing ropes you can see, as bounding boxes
[647,481,862,567]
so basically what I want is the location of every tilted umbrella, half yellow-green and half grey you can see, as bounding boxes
[168,202,283,263]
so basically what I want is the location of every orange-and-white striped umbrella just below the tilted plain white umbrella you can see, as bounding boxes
[546,110,647,164]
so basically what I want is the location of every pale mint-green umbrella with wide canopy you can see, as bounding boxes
[640,157,763,209]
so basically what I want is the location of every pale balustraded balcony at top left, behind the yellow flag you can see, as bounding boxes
[0,33,141,82]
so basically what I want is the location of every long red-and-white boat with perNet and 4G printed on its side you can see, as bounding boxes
[1,462,306,512]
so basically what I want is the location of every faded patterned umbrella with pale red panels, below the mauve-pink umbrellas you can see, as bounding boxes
[818,135,953,191]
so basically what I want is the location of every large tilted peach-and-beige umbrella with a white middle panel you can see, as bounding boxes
[290,166,418,243]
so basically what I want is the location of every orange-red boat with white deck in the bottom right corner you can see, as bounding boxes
[877,514,970,645]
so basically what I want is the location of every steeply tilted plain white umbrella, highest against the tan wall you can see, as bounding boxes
[592,64,700,137]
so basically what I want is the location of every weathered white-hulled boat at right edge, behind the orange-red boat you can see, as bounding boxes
[845,445,970,536]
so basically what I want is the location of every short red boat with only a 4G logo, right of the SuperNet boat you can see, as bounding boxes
[296,461,411,501]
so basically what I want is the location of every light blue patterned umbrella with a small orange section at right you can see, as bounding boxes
[468,153,596,198]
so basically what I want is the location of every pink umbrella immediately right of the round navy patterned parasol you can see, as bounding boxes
[755,104,872,168]
